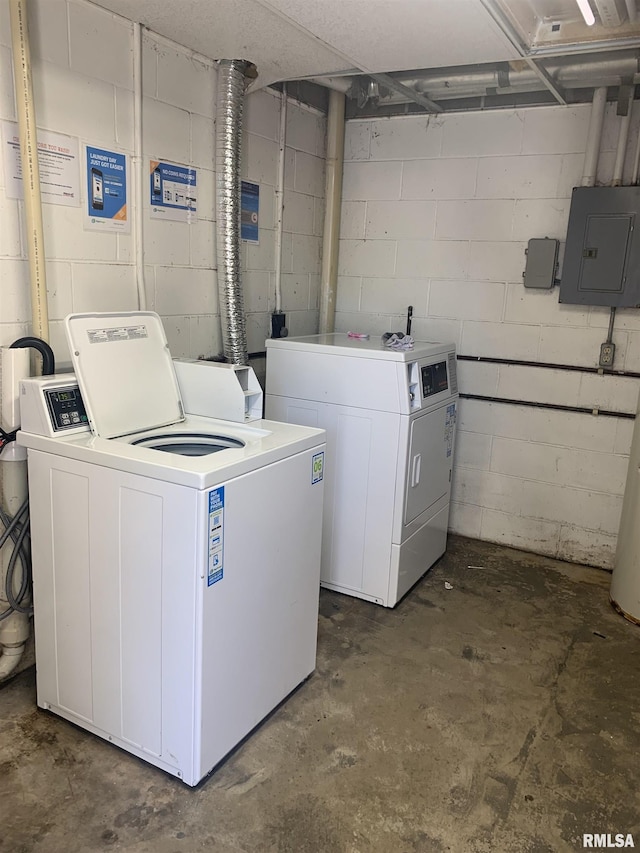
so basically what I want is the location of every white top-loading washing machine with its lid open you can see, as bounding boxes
[18,312,324,785]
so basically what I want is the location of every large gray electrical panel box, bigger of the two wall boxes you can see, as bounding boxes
[560,187,640,308]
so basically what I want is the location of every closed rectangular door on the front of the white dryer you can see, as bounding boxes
[404,403,455,524]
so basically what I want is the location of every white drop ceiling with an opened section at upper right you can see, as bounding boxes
[95,0,640,105]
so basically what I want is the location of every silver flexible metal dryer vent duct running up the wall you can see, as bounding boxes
[216,59,255,364]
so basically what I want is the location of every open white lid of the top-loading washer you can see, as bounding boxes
[65,311,184,438]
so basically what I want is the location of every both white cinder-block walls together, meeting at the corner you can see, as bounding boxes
[0,0,640,566]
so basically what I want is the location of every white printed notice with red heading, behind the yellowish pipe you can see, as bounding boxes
[2,121,80,207]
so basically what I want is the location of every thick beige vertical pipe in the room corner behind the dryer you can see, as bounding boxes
[320,90,345,334]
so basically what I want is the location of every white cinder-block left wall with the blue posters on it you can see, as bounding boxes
[0,0,325,362]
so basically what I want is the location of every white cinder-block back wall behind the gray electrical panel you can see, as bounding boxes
[336,106,640,567]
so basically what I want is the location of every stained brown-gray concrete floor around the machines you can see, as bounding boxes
[0,538,640,853]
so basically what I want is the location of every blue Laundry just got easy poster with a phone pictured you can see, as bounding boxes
[85,145,131,233]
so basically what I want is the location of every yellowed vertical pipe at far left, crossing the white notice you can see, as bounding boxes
[9,0,49,341]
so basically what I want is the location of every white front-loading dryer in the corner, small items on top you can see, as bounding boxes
[266,333,458,607]
